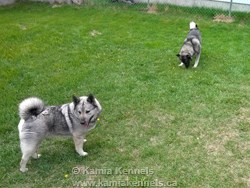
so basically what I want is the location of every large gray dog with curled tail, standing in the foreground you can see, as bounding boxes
[18,95,102,172]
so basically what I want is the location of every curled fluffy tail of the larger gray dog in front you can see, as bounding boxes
[19,97,45,120]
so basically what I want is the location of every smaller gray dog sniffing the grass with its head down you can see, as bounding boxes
[177,22,201,68]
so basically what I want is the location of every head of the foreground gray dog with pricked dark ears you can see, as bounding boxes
[73,94,102,128]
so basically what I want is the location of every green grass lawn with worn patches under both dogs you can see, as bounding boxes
[0,3,250,187]
